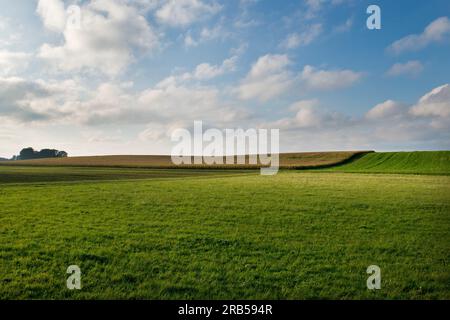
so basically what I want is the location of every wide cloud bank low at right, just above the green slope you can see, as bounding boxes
[261,84,450,151]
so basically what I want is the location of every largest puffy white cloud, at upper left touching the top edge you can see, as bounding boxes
[38,0,158,76]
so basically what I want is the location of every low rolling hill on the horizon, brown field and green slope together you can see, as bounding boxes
[0,151,450,175]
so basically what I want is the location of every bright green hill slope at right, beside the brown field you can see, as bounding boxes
[328,151,450,175]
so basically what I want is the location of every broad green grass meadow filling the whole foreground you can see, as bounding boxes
[0,154,450,299]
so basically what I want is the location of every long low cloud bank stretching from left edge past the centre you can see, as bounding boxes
[0,74,248,127]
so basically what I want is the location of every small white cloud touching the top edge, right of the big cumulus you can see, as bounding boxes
[156,0,222,27]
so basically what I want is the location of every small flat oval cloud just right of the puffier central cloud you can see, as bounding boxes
[301,65,363,90]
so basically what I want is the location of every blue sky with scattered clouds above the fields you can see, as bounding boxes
[0,0,450,158]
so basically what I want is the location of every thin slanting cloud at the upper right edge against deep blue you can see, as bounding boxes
[388,17,450,54]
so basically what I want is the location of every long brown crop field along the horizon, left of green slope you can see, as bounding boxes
[0,151,371,169]
